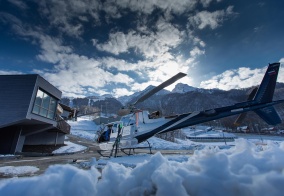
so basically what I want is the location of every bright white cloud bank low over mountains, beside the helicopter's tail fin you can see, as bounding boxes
[200,67,284,90]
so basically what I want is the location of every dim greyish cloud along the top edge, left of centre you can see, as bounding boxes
[35,0,198,37]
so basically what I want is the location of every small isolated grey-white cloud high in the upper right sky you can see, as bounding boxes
[189,6,234,29]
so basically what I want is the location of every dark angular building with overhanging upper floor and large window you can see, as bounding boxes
[0,74,70,154]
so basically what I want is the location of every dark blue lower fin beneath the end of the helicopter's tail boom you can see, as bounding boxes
[254,106,281,125]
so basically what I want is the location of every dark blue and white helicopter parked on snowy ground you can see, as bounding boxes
[98,62,284,150]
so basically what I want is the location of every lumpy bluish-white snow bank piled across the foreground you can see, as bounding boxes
[0,117,284,195]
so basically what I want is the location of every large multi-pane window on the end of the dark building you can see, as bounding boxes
[32,89,57,119]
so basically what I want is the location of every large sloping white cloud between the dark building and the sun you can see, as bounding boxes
[30,36,134,97]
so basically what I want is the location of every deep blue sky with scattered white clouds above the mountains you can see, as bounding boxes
[0,0,284,97]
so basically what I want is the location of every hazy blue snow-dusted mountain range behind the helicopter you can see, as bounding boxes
[61,83,284,127]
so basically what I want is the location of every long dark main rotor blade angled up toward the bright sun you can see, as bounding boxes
[133,72,186,105]
